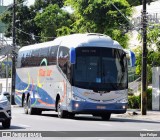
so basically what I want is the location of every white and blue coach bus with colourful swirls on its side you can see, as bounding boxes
[15,33,135,120]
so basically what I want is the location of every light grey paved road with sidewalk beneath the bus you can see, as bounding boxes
[0,106,160,140]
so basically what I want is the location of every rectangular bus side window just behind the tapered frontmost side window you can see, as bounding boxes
[48,46,58,65]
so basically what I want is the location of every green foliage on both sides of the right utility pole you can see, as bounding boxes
[136,25,160,83]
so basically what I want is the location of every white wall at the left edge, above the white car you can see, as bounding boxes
[0,78,12,93]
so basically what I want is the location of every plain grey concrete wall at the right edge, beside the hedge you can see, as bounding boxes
[152,67,160,110]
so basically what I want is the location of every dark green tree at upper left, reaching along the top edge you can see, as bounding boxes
[0,0,63,46]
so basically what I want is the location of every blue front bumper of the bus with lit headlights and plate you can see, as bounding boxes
[68,100,127,114]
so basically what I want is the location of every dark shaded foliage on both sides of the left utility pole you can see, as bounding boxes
[1,0,39,45]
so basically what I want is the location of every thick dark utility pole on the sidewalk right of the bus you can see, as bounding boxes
[141,0,147,115]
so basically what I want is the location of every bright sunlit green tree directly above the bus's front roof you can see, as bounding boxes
[65,0,132,47]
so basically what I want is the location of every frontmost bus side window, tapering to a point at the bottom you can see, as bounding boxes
[58,46,69,76]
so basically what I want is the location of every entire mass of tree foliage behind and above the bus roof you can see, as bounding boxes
[1,0,132,48]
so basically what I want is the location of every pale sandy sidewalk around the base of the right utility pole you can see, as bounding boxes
[116,109,160,121]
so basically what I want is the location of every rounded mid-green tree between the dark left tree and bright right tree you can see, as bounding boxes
[34,4,72,41]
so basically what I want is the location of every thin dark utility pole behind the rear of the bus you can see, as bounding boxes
[11,0,16,105]
